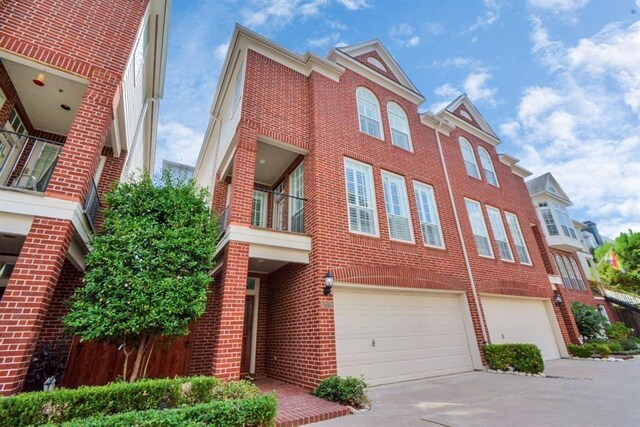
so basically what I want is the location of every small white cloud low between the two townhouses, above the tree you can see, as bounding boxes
[156,121,204,167]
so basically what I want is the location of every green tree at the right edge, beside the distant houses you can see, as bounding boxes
[595,230,640,295]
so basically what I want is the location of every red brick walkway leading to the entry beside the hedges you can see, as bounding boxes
[255,378,351,427]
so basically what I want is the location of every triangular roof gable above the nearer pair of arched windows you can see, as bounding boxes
[327,39,425,105]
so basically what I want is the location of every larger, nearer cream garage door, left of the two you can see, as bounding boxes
[334,288,473,385]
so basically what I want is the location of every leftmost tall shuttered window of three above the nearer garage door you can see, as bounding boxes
[344,159,377,234]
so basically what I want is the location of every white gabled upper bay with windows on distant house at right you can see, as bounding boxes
[527,173,583,252]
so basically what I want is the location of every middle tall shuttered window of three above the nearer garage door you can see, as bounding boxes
[382,172,413,242]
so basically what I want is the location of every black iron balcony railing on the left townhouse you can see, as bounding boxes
[0,129,62,192]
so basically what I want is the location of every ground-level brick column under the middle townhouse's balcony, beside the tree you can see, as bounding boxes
[213,241,249,380]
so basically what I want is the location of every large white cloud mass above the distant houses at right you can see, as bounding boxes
[500,19,640,237]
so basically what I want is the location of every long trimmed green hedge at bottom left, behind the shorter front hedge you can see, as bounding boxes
[0,377,260,426]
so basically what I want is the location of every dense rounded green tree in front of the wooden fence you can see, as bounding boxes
[64,174,217,381]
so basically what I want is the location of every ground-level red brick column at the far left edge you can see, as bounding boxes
[0,217,73,395]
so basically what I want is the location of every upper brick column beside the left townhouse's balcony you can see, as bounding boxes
[45,71,120,203]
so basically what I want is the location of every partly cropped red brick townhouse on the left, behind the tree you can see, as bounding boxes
[0,0,170,395]
